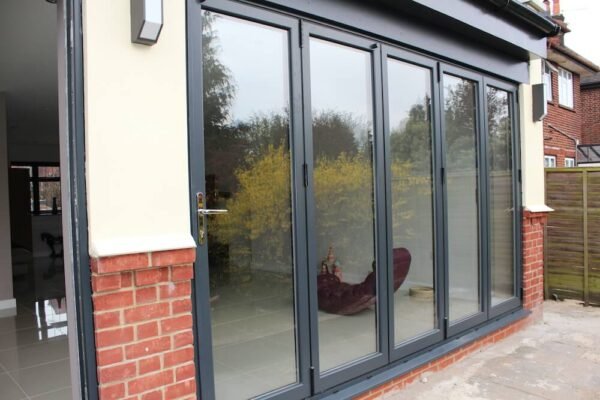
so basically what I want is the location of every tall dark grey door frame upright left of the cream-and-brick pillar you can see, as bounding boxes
[56,0,98,400]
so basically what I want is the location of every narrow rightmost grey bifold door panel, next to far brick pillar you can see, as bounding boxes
[483,77,521,318]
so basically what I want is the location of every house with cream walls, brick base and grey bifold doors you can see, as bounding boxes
[0,0,564,400]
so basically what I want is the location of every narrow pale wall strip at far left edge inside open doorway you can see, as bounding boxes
[0,92,13,300]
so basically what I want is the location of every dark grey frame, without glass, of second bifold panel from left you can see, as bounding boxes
[301,22,389,393]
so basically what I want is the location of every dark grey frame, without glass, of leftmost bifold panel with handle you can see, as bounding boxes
[187,0,312,399]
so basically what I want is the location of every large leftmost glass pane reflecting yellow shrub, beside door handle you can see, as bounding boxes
[202,11,297,400]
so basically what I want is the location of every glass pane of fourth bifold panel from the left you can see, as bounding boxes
[444,75,481,321]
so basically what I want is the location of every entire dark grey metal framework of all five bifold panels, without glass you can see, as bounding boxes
[186,0,522,399]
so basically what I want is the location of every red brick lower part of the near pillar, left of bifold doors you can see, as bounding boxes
[91,249,196,400]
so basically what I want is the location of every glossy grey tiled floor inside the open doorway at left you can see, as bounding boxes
[0,255,71,400]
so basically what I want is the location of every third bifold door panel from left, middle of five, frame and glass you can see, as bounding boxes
[382,46,445,359]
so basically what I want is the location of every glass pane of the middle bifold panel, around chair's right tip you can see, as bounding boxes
[387,59,436,344]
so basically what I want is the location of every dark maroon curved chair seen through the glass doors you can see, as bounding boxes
[317,247,411,315]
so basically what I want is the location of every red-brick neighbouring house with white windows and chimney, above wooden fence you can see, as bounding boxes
[544,0,600,168]
